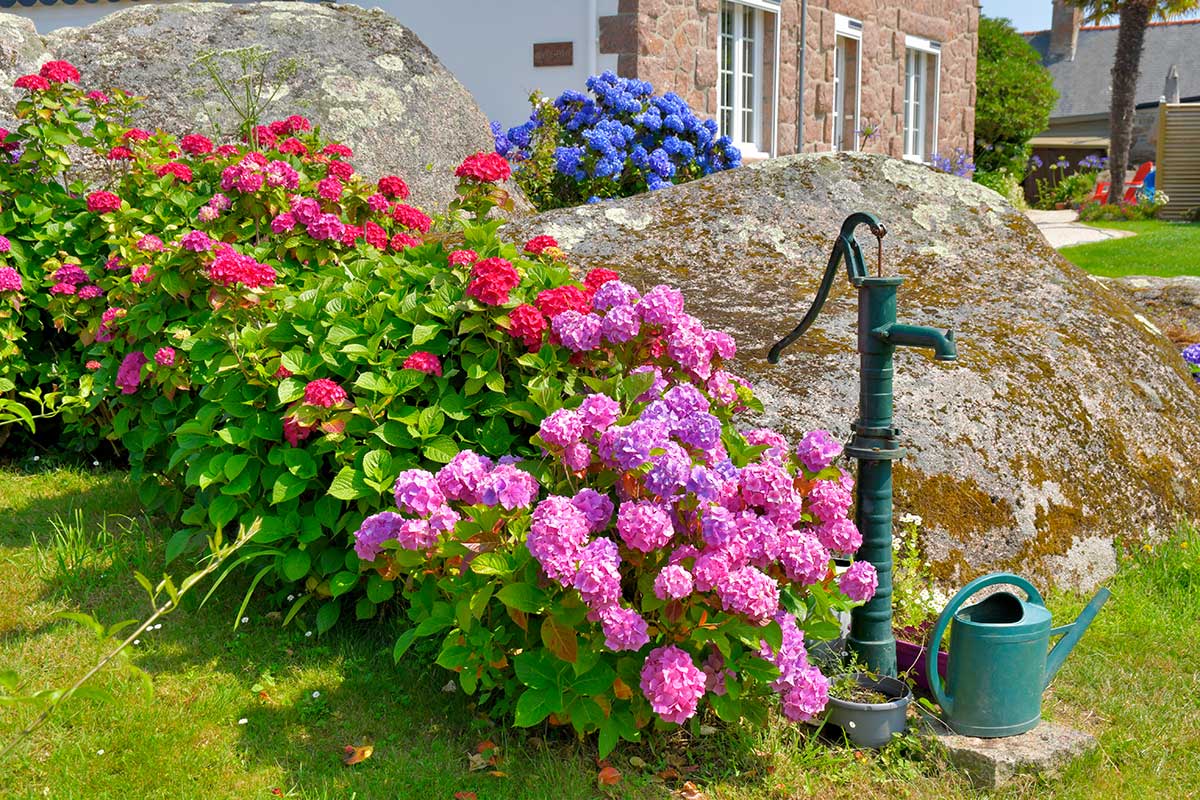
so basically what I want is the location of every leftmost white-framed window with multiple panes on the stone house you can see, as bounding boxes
[716,0,779,154]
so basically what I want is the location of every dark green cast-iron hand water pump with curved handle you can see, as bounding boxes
[767,211,958,675]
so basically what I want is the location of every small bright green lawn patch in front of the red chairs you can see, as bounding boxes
[1058,219,1200,278]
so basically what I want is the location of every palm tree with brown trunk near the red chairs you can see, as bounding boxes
[1069,0,1200,203]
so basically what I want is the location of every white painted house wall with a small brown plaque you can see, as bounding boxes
[356,0,617,128]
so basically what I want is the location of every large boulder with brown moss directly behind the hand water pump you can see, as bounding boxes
[510,155,1200,587]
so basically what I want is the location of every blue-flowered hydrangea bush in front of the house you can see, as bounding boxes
[492,72,742,211]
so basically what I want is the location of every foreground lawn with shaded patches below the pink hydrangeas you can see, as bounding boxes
[0,469,1200,800]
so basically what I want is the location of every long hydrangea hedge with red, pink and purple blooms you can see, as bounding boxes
[0,65,875,752]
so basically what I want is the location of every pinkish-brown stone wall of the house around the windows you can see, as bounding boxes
[600,0,979,157]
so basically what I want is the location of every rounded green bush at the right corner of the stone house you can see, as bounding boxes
[976,17,1058,175]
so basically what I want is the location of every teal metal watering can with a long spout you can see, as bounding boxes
[926,572,1109,738]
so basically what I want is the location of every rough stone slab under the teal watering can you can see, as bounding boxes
[918,716,1096,789]
